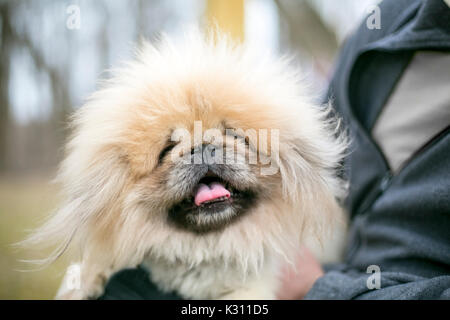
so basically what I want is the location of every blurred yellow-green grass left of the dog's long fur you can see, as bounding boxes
[0,177,67,299]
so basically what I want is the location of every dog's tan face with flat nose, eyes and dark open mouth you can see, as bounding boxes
[124,84,282,234]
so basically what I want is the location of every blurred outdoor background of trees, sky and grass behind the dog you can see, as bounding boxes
[0,0,376,299]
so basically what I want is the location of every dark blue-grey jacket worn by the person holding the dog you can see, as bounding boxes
[307,0,450,299]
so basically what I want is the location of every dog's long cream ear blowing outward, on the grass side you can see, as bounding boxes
[20,131,128,265]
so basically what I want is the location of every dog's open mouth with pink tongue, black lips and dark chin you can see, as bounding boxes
[169,171,256,233]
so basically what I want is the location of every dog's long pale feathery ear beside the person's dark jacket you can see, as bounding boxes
[279,106,348,242]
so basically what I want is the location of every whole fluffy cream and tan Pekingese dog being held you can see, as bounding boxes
[29,32,346,299]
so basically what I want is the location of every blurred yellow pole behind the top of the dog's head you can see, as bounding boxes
[206,0,244,42]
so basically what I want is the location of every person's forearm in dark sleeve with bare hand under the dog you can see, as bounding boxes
[277,249,450,300]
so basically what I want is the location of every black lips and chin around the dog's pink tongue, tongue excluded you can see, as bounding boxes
[168,175,257,234]
